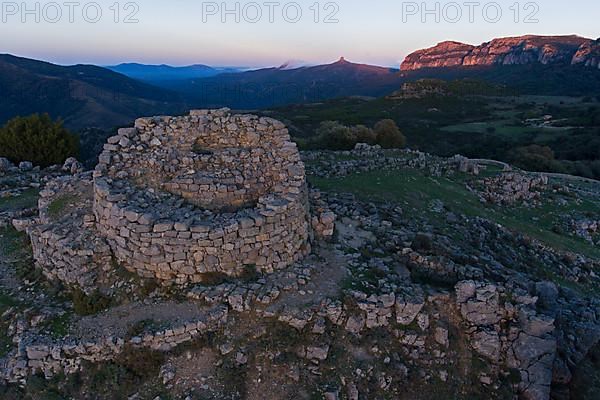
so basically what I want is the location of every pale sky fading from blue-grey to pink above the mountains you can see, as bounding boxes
[0,0,600,67]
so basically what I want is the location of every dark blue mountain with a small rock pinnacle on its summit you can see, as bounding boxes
[157,57,402,109]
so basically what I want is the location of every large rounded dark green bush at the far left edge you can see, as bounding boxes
[0,114,79,167]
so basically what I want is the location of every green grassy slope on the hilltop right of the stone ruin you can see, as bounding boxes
[310,170,600,258]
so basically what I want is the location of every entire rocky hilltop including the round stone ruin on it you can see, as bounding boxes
[0,115,600,400]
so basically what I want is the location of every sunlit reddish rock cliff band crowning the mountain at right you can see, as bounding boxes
[400,35,600,71]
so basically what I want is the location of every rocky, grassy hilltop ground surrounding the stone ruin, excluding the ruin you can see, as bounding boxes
[0,147,600,400]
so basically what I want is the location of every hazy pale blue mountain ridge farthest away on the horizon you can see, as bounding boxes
[106,63,240,82]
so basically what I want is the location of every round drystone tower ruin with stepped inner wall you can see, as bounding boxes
[93,109,310,283]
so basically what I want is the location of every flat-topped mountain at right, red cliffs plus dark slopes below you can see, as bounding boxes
[400,35,600,96]
